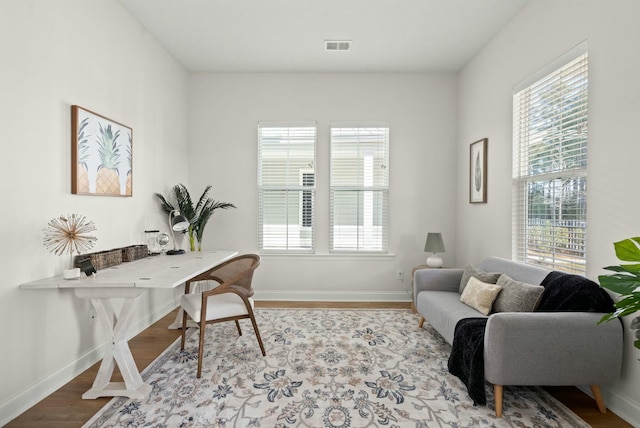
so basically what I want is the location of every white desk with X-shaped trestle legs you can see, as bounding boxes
[20,251,237,399]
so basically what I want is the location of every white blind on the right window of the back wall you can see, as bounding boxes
[329,123,389,253]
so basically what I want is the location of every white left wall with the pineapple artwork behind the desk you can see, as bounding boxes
[0,0,188,425]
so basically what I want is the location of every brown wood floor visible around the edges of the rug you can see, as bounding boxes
[6,302,632,428]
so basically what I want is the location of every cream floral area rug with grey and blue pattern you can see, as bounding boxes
[85,309,589,428]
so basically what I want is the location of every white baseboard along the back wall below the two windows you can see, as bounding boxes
[253,291,411,302]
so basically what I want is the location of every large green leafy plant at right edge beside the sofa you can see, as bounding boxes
[598,237,640,349]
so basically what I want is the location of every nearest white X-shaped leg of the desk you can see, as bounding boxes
[75,288,151,399]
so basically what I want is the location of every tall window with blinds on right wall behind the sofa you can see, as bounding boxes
[513,43,588,274]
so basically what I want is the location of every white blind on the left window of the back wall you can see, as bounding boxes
[258,122,316,252]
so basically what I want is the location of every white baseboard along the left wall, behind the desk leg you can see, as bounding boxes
[0,299,176,427]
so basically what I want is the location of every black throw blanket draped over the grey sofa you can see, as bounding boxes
[448,271,614,405]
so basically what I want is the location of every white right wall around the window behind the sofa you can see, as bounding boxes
[456,0,640,426]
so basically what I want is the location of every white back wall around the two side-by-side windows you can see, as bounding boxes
[189,74,457,300]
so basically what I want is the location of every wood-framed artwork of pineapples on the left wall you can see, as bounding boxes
[71,105,133,196]
